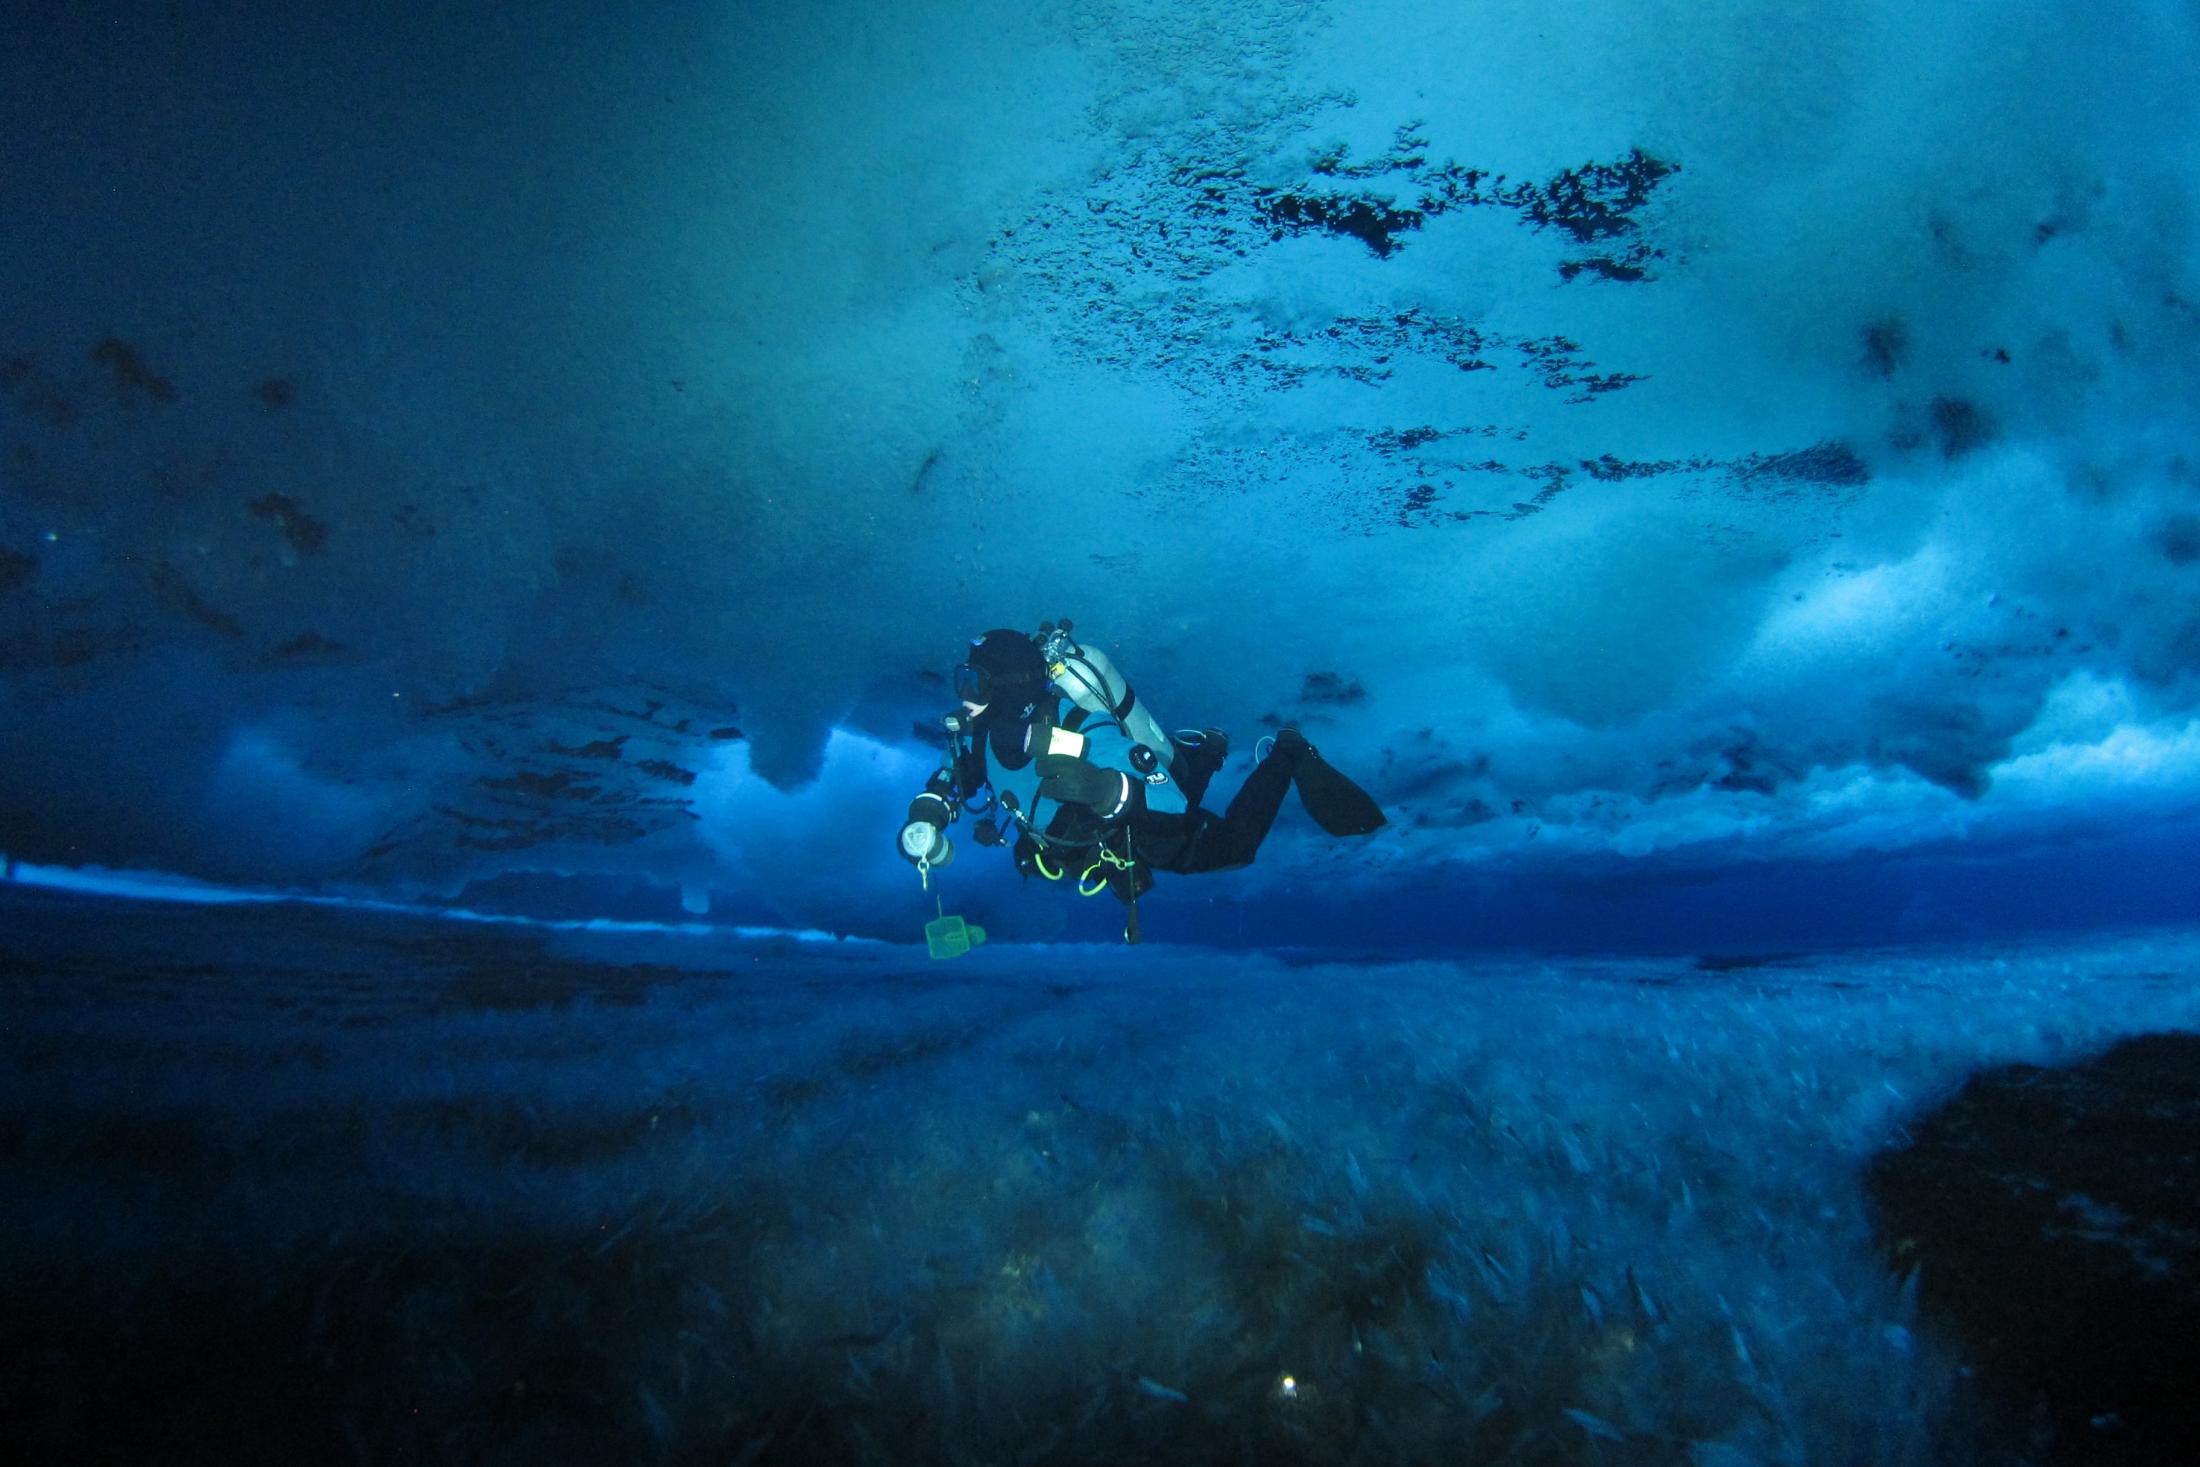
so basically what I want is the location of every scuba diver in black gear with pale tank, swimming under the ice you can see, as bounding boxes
[900,620,1386,941]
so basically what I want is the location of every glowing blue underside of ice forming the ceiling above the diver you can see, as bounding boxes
[0,0,2200,930]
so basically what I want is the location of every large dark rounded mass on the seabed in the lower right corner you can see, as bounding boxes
[1866,1034,2200,1463]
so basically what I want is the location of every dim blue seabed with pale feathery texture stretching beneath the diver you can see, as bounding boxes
[0,891,2200,1465]
